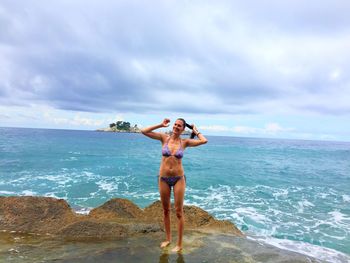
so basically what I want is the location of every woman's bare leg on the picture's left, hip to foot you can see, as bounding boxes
[158,177,171,248]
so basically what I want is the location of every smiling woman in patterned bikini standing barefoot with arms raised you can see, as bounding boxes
[141,118,208,252]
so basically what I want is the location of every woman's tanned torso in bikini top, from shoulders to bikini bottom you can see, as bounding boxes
[159,137,185,176]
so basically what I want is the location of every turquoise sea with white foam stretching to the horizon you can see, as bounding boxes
[0,128,350,262]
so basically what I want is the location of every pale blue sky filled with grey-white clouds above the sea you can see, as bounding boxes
[0,0,350,141]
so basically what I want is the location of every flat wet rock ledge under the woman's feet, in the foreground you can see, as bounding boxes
[0,231,328,263]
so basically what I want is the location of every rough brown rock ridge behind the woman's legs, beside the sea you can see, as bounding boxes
[0,197,243,239]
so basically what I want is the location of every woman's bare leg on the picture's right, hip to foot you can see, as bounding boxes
[173,177,186,252]
